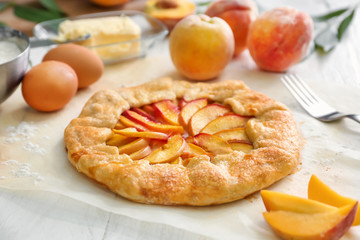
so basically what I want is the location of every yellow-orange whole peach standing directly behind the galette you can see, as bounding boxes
[169,14,234,80]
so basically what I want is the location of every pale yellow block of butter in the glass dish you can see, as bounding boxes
[59,16,141,61]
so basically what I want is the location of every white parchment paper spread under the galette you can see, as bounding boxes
[0,46,360,239]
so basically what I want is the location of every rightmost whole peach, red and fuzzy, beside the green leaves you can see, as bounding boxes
[247,7,313,72]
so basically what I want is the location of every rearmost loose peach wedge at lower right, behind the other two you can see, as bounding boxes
[308,175,360,226]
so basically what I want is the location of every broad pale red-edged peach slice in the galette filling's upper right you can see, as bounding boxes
[189,103,230,136]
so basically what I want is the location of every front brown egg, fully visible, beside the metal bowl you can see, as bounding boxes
[21,61,78,112]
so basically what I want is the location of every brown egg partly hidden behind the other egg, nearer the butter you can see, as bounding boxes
[43,43,104,88]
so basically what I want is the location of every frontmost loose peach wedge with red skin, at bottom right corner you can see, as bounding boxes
[263,203,357,240]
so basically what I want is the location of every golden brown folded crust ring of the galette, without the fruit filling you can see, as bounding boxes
[64,78,299,206]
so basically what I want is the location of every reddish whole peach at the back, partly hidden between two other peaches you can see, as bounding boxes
[205,0,258,55]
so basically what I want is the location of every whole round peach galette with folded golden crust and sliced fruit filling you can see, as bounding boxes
[65,78,299,205]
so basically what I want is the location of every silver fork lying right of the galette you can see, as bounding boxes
[281,74,360,123]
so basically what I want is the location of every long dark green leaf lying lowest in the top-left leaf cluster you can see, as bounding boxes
[14,5,64,23]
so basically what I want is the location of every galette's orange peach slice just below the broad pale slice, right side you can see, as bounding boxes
[200,114,249,134]
